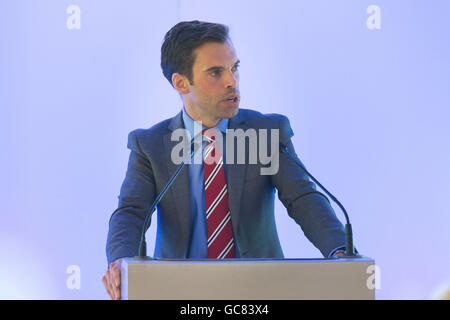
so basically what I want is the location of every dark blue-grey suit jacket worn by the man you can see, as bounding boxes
[106,109,345,263]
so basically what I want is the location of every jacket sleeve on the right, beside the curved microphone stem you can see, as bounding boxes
[272,116,345,257]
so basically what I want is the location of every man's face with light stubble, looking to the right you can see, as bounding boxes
[184,41,240,127]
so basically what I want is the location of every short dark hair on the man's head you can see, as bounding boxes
[161,20,229,86]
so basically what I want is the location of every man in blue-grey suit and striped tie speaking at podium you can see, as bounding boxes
[103,21,345,299]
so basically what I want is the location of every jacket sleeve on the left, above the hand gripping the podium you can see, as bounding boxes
[106,130,155,265]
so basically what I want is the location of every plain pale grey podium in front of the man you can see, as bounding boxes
[121,257,375,300]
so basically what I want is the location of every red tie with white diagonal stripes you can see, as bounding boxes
[202,129,234,259]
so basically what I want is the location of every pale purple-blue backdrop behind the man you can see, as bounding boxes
[0,0,450,299]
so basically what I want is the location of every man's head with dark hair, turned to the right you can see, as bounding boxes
[161,21,240,127]
